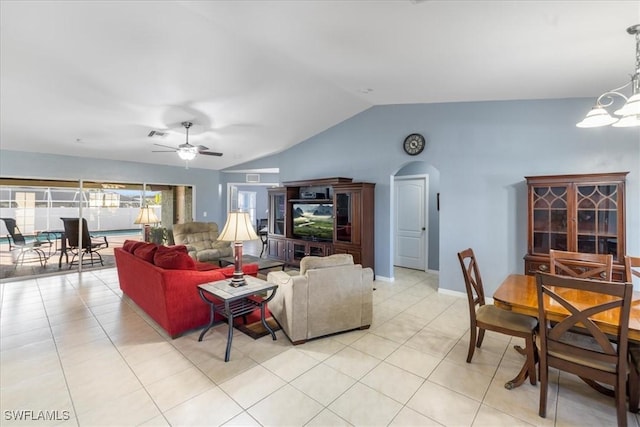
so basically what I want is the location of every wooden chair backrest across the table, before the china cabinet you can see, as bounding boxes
[549,249,613,281]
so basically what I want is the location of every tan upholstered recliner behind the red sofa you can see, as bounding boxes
[173,222,233,262]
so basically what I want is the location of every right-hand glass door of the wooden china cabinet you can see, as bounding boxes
[576,184,619,261]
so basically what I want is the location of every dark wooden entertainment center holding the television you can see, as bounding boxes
[267,178,375,268]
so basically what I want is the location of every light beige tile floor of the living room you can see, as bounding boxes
[0,268,638,426]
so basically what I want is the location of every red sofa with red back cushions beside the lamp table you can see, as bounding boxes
[114,241,258,338]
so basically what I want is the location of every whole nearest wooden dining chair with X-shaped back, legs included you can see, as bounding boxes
[536,273,633,426]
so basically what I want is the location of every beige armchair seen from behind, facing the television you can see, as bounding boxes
[267,254,373,345]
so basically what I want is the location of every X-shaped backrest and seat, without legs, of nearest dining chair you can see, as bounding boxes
[536,273,633,373]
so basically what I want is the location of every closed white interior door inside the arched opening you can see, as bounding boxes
[394,176,428,270]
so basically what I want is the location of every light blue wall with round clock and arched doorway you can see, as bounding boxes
[230,99,640,295]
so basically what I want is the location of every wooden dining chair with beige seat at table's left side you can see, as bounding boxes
[458,248,538,389]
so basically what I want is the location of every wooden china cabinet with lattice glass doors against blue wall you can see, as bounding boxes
[524,172,629,281]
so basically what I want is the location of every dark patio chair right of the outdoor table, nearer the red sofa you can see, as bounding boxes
[60,218,109,268]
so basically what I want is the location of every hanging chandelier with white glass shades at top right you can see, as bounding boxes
[576,24,640,128]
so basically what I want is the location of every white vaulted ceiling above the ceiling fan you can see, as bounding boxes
[0,0,640,170]
